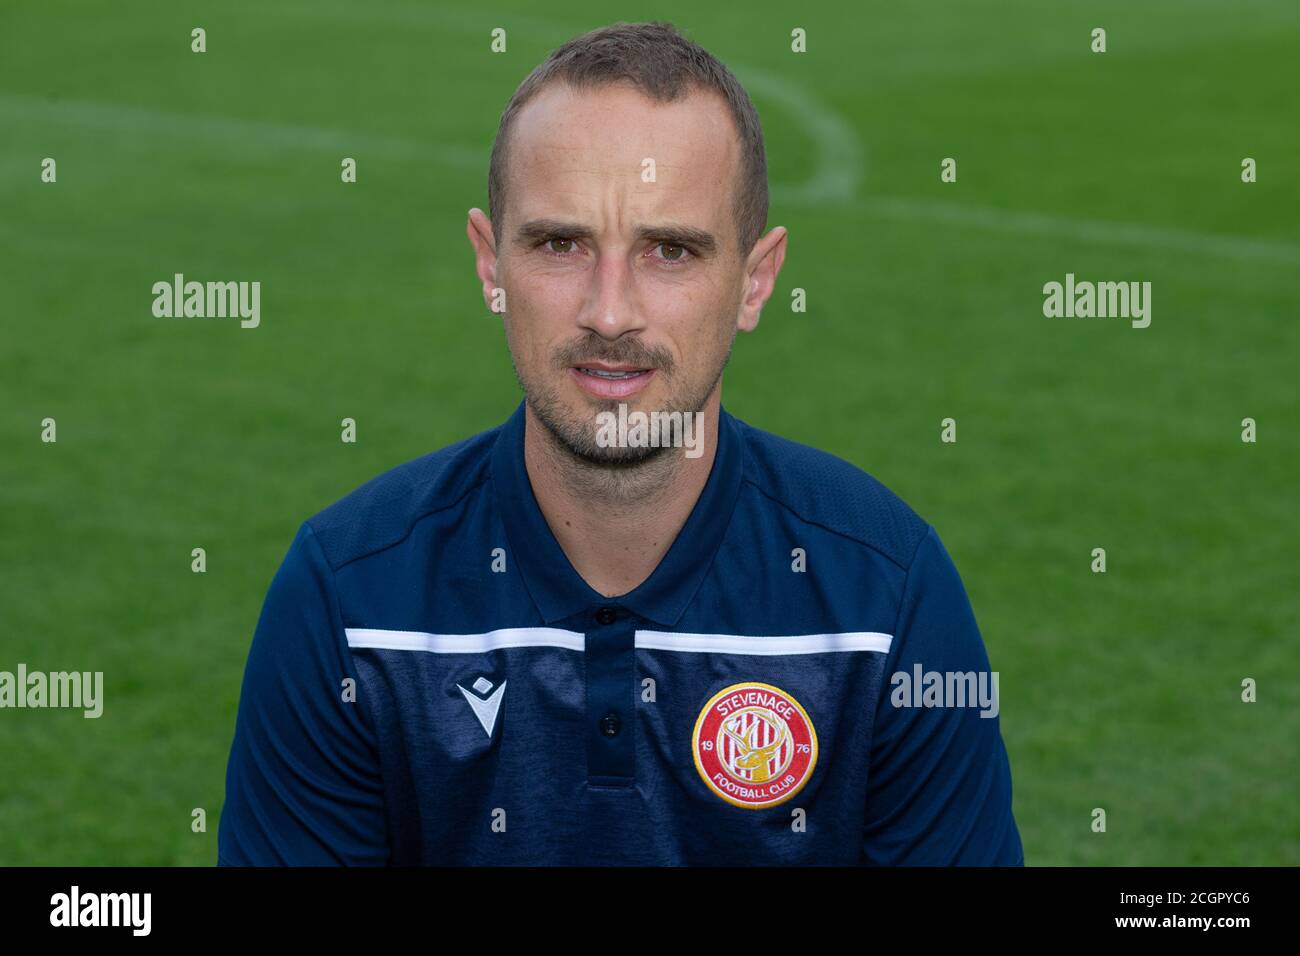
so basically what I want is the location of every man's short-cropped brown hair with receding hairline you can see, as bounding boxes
[488,23,767,256]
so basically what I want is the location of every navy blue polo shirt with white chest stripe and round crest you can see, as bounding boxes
[218,403,1023,865]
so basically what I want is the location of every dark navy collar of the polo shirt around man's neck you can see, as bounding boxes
[491,402,745,627]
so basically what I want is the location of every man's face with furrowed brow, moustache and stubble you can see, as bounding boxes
[495,83,757,464]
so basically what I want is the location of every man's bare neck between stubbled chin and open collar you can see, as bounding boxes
[524,389,722,597]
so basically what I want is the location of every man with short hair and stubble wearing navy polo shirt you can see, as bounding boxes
[218,23,1023,865]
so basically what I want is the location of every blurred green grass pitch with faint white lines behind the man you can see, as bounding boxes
[0,0,1300,865]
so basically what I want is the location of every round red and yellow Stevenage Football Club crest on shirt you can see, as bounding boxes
[690,680,816,810]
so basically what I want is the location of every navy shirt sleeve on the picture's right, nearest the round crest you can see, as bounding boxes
[863,528,1024,866]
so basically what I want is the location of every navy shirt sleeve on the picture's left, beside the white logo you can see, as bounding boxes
[217,523,389,866]
